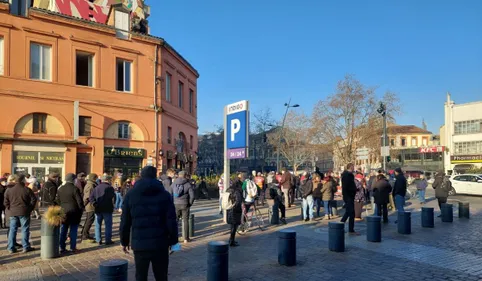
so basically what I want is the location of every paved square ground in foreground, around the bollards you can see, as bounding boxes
[0,188,482,281]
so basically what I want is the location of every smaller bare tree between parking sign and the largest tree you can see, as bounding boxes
[268,111,314,172]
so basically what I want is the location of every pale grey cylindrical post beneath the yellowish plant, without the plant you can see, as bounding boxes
[40,219,60,260]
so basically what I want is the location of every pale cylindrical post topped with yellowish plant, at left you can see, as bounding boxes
[40,206,65,259]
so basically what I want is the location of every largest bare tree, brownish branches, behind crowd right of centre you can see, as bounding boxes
[312,75,399,168]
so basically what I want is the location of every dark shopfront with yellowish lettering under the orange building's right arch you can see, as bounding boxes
[104,147,146,178]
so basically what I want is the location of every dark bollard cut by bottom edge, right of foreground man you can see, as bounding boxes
[207,241,229,281]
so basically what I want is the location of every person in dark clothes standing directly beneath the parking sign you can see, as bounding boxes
[226,173,245,247]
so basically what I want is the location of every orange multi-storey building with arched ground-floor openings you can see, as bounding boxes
[0,0,199,178]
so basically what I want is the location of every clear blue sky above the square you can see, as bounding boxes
[146,0,482,134]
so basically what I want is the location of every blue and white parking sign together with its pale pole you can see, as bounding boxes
[224,100,249,222]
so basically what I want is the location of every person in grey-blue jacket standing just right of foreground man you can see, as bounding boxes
[172,171,195,243]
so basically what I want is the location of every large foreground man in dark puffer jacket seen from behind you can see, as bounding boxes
[120,166,178,280]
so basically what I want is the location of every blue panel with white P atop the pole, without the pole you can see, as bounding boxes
[225,100,249,159]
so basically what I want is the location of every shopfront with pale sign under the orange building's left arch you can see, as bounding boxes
[12,151,65,179]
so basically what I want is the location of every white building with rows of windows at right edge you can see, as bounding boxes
[440,94,482,172]
